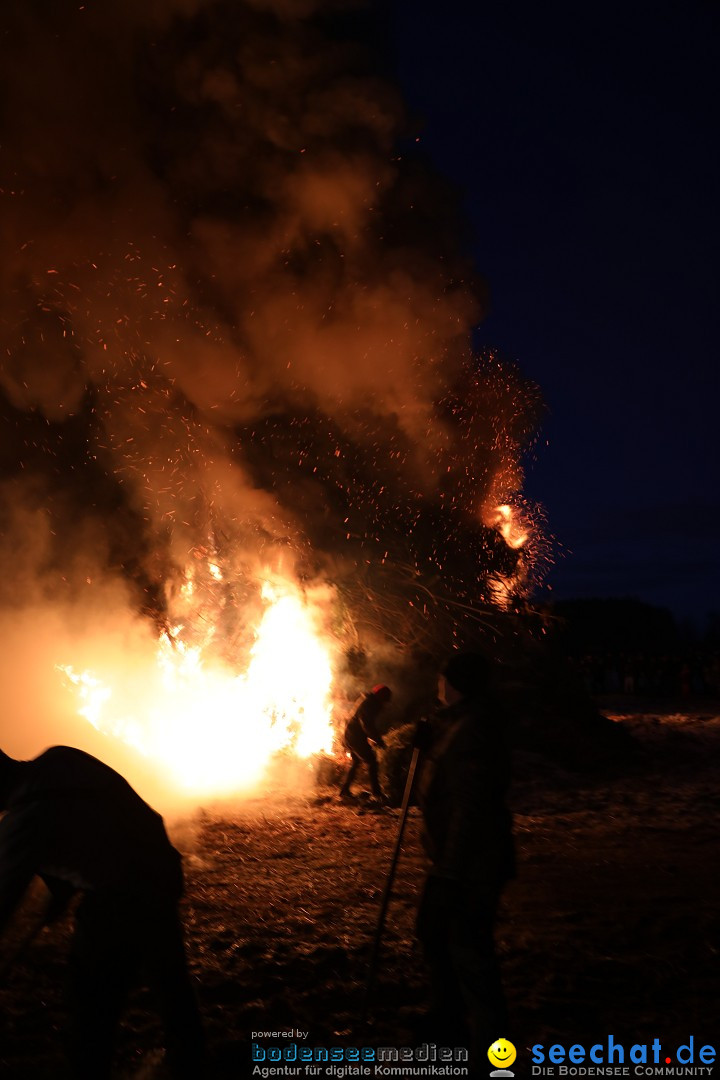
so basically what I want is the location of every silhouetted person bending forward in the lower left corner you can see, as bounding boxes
[0,746,203,1080]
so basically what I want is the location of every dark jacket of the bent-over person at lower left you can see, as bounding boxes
[0,746,182,932]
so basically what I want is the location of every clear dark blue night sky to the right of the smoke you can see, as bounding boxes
[395,0,720,620]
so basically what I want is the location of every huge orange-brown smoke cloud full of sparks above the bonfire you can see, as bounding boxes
[0,0,540,787]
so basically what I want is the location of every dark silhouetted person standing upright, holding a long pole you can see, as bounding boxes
[417,652,515,1067]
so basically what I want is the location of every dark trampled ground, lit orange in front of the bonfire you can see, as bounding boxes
[0,708,720,1080]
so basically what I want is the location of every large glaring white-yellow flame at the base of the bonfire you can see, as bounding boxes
[58,571,332,795]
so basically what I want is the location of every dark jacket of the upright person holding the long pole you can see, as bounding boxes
[418,699,515,888]
